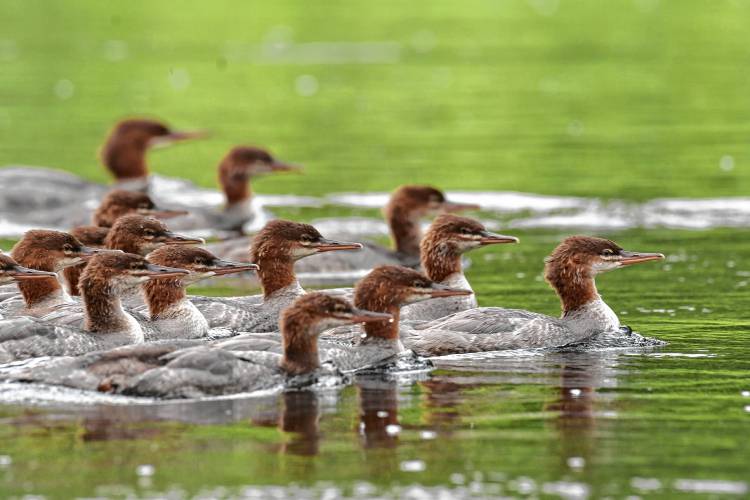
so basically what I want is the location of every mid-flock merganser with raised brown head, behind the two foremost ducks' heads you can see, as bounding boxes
[191,219,362,332]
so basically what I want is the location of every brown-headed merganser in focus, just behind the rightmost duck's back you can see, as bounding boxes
[401,214,518,321]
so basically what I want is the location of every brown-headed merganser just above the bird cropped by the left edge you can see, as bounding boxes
[0,229,101,316]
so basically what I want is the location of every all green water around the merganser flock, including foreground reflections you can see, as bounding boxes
[0,0,750,498]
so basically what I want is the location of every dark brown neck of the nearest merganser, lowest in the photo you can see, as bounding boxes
[281,315,320,375]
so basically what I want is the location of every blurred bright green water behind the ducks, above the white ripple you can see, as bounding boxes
[0,0,750,199]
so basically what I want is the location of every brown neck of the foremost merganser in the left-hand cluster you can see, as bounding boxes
[81,280,130,333]
